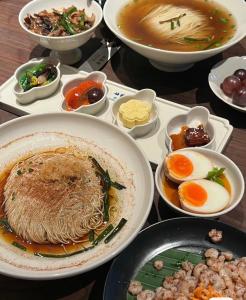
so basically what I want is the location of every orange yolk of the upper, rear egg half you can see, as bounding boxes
[167,154,193,178]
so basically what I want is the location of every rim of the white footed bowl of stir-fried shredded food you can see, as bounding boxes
[18,0,103,40]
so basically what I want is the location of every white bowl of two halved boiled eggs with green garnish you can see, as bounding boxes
[155,148,245,218]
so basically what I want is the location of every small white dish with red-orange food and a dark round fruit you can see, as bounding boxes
[61,71,107,115]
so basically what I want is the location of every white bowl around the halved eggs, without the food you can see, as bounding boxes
[155,147,245,218]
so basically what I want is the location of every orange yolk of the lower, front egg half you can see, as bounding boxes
[182,182,208,206]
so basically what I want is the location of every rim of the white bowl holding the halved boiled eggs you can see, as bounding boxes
[155,148,245,218]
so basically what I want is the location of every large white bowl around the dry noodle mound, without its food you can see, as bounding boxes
[0,113,154,279]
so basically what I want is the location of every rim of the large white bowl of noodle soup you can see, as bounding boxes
[103,0,246,56]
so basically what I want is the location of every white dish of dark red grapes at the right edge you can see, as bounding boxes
[208,56,246,112]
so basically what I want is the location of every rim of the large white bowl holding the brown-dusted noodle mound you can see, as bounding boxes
[0,112,154,280]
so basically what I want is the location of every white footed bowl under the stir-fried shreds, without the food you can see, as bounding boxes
[19,0,102,64]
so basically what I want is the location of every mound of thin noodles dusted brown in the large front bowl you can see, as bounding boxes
[4,152,106,244]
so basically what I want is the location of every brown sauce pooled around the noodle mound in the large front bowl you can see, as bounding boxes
[0,158,117,255]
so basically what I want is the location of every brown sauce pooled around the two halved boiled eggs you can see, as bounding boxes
[162,175,231,208]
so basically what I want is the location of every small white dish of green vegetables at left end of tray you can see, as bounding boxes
[14,58,60,104]
